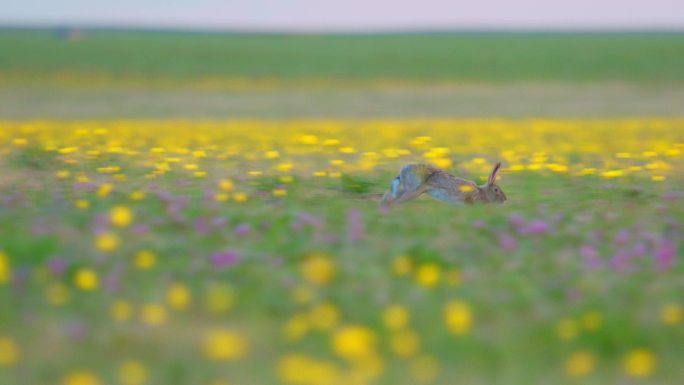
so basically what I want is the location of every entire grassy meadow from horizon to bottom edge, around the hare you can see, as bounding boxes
[0,30,684,385]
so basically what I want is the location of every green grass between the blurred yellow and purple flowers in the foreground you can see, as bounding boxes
[0,148,684,385]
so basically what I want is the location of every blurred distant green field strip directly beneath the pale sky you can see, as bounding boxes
[0,30,684,83]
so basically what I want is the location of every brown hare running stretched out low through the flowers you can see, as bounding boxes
[380,162,507,206]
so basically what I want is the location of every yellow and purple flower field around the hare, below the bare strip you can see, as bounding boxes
[0,117,684,385]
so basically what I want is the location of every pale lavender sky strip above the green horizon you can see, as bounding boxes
[0,0,684,31]
